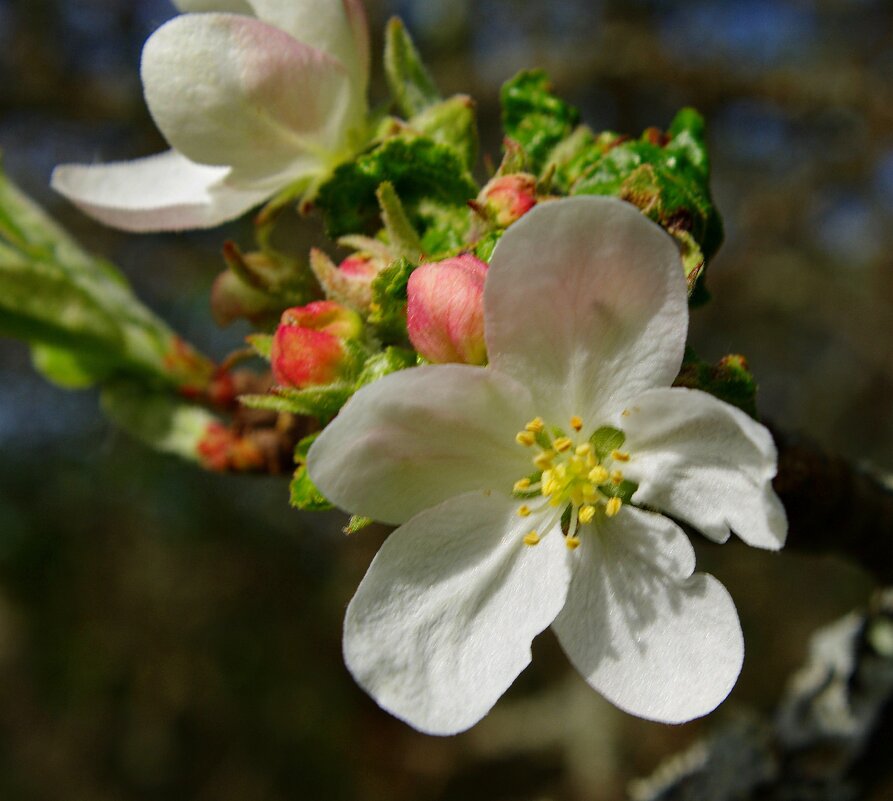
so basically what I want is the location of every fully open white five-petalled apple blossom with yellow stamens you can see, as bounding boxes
[309,197,786,734]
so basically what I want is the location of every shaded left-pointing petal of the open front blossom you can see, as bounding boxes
[308,364,533,523]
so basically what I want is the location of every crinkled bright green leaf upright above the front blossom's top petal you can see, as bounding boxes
[499,70,580,174]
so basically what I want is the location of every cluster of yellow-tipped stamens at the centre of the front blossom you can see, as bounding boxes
[512,416,637,549]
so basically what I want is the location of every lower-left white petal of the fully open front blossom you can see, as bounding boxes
[344,493,569,734]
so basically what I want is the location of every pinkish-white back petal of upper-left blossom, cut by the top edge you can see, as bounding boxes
[249,0,369,90]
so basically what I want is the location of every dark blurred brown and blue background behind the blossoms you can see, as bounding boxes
[0,0,893,801]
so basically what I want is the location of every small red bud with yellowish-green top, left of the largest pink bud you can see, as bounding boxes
[270,300,363,389]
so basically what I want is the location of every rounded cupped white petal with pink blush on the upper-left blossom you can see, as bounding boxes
[141,14,357,181]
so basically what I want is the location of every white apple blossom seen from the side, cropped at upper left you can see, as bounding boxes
[52,0,369,231]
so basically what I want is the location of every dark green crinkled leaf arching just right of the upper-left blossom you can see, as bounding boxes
[316,133,478,240]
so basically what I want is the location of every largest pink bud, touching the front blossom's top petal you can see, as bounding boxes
[406,254,487,364]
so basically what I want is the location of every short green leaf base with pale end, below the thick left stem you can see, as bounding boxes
[100,382,217,462]
